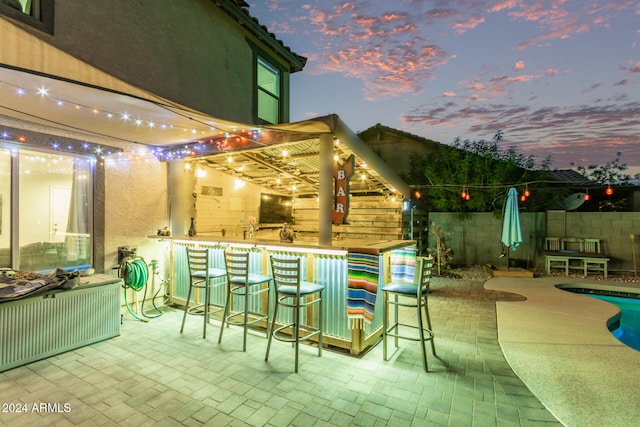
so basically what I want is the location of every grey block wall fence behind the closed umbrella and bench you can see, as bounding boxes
[429,210,640,272]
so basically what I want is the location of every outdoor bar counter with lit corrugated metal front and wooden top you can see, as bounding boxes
[149,236,416,355]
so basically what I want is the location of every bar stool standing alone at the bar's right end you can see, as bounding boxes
[382,257,436,372]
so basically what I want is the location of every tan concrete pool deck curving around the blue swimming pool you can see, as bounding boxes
[485,276,640,426]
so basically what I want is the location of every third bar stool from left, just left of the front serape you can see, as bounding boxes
[264,256,324,373]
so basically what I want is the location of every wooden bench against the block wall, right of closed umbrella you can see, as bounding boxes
[544,237,609,278]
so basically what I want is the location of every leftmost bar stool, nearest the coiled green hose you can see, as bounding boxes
[180,247,226,338]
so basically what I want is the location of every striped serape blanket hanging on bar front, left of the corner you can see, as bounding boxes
[347,252,380,329]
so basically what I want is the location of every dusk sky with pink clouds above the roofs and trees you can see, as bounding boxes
[248,0,640,173]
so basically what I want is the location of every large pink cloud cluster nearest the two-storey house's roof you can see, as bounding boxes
[310,3,449,100]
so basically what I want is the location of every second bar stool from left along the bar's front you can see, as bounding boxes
[218,251,271,351]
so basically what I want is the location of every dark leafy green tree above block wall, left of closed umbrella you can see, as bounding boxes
[409,130,551,212]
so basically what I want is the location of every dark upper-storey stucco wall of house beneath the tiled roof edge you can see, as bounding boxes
[7,0,297,123]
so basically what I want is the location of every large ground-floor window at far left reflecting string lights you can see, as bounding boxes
[0,145,95,271]
